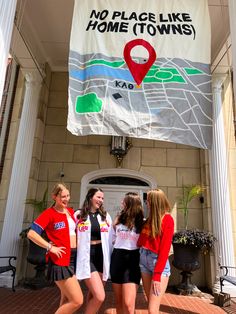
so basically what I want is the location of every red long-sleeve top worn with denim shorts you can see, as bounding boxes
[137,214,174,281]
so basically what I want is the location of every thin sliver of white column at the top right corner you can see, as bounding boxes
[228,0,236,102]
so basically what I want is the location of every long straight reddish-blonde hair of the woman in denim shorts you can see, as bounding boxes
[146,189,171,238]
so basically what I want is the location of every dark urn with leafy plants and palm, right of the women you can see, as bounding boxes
[172,185,216,294]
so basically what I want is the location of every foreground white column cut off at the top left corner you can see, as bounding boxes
[0,0,17,106]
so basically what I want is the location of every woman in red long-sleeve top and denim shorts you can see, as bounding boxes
[138,189,174,313]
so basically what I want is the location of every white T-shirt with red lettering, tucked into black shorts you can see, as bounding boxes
[113,224,139,250]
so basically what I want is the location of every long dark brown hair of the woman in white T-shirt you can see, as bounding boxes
[116,192,144,233]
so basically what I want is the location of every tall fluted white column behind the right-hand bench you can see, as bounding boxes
[209,75,236,296]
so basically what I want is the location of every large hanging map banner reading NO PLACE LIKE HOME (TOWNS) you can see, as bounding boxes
[67,0,212,148]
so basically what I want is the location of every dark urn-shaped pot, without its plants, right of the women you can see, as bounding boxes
[172,243,201,294]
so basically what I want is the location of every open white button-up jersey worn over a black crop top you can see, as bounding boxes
[74,210,113,281]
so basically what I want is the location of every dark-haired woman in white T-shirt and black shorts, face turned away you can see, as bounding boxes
[111,192,144,314]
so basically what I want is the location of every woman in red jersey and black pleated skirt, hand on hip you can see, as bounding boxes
[28,183,83,314]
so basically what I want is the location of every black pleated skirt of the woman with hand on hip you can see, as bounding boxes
[47,248,76,282]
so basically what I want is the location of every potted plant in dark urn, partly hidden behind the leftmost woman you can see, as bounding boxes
[20,189,48,289]
